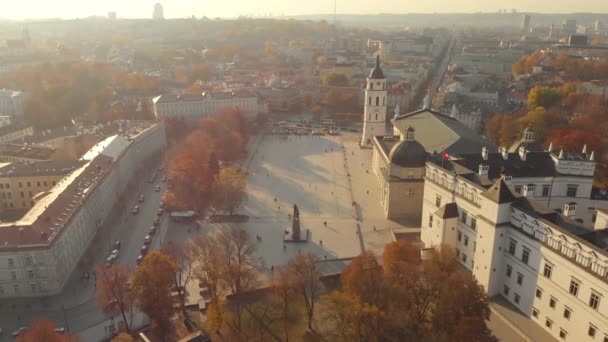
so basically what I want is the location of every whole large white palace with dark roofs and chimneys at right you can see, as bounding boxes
[421,142,608,341]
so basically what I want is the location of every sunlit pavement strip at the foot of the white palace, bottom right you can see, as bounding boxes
[490,296,557,342]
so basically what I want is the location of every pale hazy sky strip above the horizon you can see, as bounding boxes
[0,0,608,19]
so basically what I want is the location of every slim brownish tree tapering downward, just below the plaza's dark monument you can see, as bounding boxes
[288,253,323,330]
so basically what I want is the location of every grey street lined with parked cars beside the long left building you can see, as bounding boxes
[0,157,170,341]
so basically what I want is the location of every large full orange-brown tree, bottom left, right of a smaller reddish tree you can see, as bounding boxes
[130,251,179,336]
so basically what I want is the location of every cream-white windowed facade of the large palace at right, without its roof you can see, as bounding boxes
[421,164,608,341]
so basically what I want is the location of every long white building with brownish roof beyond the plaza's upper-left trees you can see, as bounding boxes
[152,90,265,123]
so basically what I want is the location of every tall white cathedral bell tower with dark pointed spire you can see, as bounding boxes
[361,56,387,146]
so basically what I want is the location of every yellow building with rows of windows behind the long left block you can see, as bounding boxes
[0,160,85,211]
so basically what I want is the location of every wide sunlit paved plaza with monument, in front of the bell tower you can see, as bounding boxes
[206,133,395,270]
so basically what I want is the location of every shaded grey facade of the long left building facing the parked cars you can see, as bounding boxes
[0,124,166,298]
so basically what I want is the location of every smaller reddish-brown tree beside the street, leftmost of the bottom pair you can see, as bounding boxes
[95,265,133,333]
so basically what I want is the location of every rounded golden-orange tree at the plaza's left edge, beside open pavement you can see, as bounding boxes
[211,166,246,215]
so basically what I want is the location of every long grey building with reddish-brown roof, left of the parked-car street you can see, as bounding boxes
[0,122,166,298]
